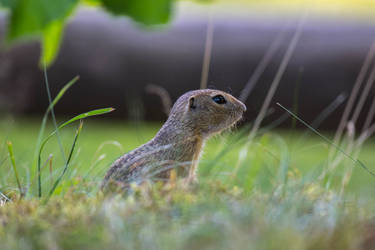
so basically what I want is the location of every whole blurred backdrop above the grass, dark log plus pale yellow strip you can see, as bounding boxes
[0,1,375,129]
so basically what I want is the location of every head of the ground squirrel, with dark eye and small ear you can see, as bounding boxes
[169,89,246,137]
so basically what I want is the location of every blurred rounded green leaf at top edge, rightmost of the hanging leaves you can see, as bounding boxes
[101,0,173,25]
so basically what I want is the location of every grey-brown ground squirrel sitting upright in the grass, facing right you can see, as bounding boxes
[102,89,246,187]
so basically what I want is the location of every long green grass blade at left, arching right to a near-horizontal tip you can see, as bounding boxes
[38,108,115,198]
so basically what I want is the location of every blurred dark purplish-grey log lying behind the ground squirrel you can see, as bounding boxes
[0,9,375,127]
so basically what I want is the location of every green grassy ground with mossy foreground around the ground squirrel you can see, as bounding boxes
[0,118,375,249]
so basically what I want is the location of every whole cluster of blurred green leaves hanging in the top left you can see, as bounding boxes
[0,0,174,65]
